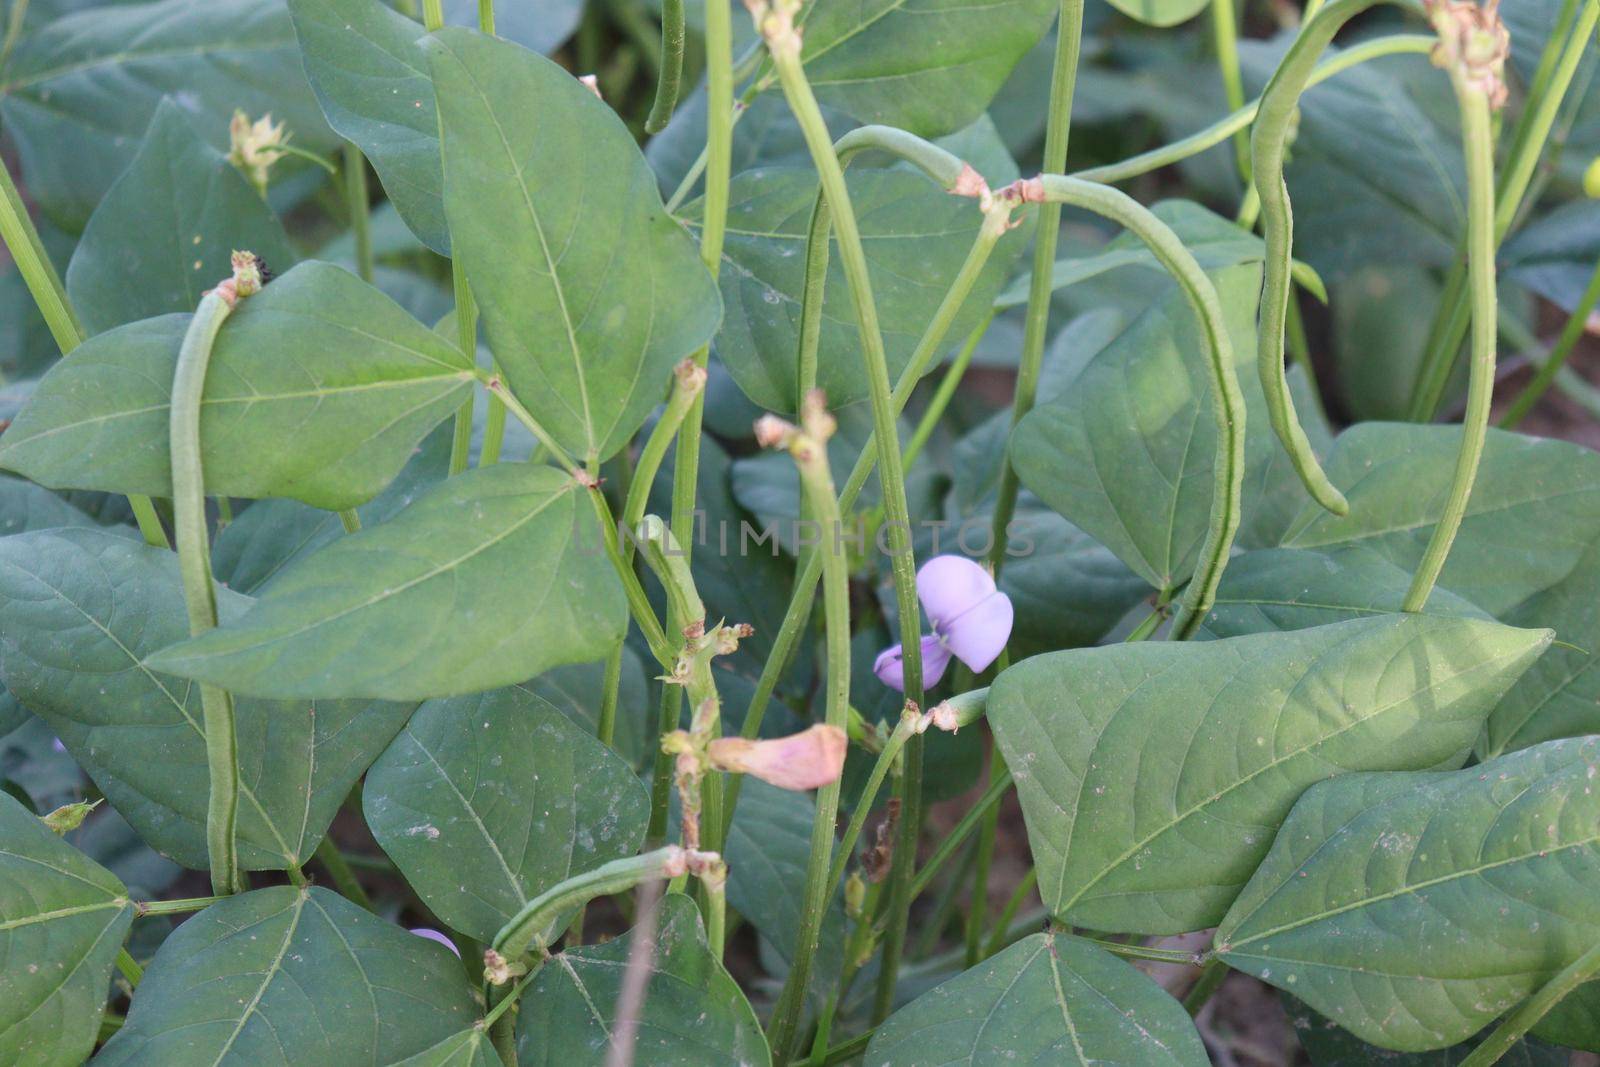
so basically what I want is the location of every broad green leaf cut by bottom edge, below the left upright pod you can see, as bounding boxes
[94,886,478,1067]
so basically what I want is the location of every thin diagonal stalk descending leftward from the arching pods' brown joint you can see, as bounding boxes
[720,217,1011,833]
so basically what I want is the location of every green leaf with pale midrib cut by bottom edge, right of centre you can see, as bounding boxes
[866,934,1210,1067]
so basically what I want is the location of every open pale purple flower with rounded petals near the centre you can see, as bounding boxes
[872,555,1013,693]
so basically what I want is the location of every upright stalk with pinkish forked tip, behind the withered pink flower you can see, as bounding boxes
[766,405,850,1062]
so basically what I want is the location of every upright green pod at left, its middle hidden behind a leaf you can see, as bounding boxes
[170,291,245,894]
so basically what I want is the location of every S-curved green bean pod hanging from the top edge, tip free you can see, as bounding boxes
[1250,0,1414,515]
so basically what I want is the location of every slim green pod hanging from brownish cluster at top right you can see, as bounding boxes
[1402,80,1498,611]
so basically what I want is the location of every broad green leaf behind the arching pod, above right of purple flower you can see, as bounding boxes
[1010,264,1277,589]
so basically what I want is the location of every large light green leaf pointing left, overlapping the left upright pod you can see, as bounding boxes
[150,464,627,699]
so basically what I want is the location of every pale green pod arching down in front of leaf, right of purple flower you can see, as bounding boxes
[1040,178,1248,640]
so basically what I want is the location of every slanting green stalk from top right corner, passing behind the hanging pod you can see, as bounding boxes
[1408,0,1600,422]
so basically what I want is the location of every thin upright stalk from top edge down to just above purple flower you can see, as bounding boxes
[989,0,1083,577]
